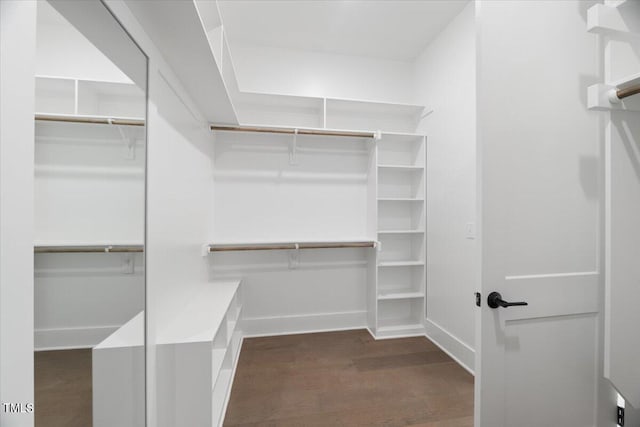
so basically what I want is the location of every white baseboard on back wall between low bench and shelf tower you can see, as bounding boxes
[242,311,367,338]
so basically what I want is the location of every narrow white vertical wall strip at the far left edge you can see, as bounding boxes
[0,1,36,427]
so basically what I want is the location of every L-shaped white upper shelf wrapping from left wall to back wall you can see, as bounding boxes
[119,0,425,133]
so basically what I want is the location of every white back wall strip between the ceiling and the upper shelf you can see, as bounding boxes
[231,44,413,103]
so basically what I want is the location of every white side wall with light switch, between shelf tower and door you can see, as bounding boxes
[414,2,479,370]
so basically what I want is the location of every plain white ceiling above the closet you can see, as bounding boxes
[219,0,468,61]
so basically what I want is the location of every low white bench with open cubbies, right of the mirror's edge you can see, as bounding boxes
[157,280,243,426]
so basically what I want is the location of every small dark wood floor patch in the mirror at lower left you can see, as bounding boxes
[34,349,92,427]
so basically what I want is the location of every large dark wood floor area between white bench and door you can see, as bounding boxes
[225,330,473,427]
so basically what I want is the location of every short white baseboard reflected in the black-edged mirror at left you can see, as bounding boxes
[34,326,119,351]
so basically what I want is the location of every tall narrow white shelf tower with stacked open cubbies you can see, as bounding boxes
[370,133,426,338]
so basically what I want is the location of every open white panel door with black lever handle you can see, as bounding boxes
[476,1,614,427]
